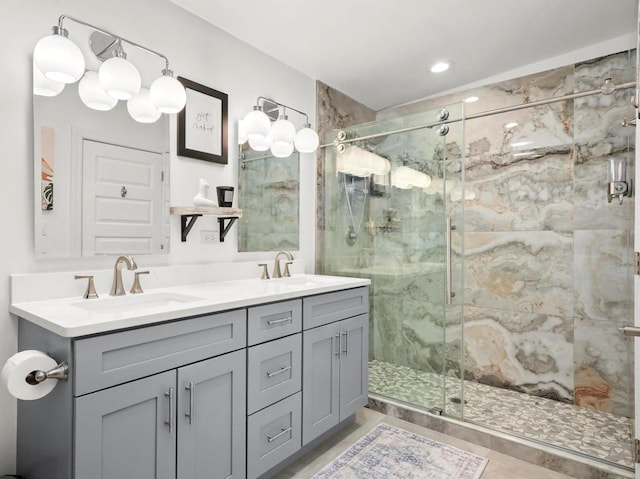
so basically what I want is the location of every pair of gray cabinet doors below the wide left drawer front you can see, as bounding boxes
[75,350,246,479]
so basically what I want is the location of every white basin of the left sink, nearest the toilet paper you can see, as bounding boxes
[72,292,203,314]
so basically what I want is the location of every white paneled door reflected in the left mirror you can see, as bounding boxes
[82,140,163,256]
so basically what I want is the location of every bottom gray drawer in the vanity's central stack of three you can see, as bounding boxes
[247,393,301,479]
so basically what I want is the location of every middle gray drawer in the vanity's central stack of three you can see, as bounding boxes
[247,333,302,414]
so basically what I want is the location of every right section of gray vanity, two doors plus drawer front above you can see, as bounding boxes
[302,288,369,446]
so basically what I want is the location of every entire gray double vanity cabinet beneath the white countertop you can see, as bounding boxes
[17,287,369,479]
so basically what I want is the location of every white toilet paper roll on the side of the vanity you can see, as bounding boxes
[0,349,58,401]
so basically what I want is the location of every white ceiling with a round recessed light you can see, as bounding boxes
[171,0,638,110]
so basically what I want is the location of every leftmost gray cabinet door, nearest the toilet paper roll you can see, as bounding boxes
[74,371,176,479]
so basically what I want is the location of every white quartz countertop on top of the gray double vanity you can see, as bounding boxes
[9,274,370,337]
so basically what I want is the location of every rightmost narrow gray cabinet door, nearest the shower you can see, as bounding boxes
[340,314,369,421]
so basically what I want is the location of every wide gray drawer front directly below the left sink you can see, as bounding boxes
[74,309,247,396]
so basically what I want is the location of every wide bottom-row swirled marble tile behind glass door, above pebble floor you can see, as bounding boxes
[464,307,573,402]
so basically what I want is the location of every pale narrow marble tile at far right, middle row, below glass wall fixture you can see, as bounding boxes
[573,230,633,324]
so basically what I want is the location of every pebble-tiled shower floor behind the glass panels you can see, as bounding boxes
[369,360,634,477]
